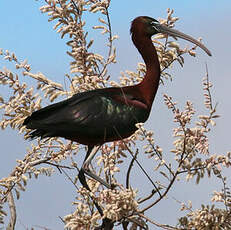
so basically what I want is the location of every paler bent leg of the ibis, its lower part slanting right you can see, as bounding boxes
[81,145,111,189]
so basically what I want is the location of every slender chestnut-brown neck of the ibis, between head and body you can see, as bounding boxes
[132,34,160,108]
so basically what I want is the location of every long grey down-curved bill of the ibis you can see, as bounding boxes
[156,24,212,56]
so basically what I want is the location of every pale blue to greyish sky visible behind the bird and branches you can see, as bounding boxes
[0,0,231,229]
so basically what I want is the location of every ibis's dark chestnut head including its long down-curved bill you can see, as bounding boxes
[130,16,212,56]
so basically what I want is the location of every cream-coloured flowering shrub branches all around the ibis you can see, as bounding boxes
[0,0,231,230]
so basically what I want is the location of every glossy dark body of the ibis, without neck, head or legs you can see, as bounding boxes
[24,87,150,145]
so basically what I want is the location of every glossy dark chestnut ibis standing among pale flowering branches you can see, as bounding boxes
[23,16,211,189]
